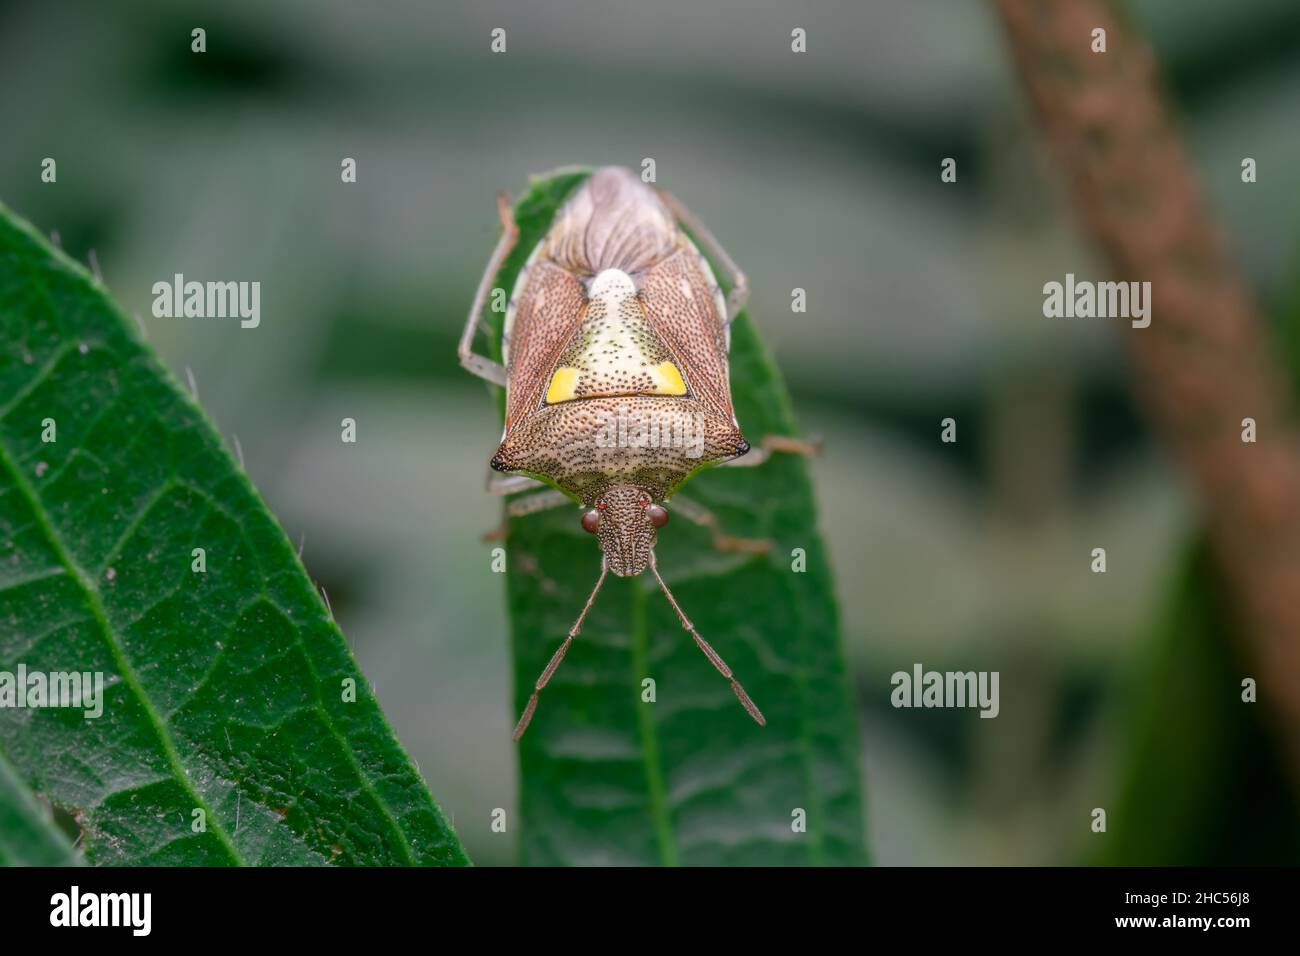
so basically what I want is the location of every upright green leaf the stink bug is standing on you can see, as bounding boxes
[489,170,866,865]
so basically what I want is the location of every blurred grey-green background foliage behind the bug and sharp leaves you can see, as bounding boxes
[0,0,1300,864]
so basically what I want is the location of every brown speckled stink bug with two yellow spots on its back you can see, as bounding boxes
[459,166,813,740]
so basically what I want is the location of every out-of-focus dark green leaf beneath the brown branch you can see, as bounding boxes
[1096,540,1300,866]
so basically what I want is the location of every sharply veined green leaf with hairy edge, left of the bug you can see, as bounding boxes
[0,207,467,865]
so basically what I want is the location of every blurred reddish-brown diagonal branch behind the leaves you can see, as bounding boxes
[996,0,1300,780]
